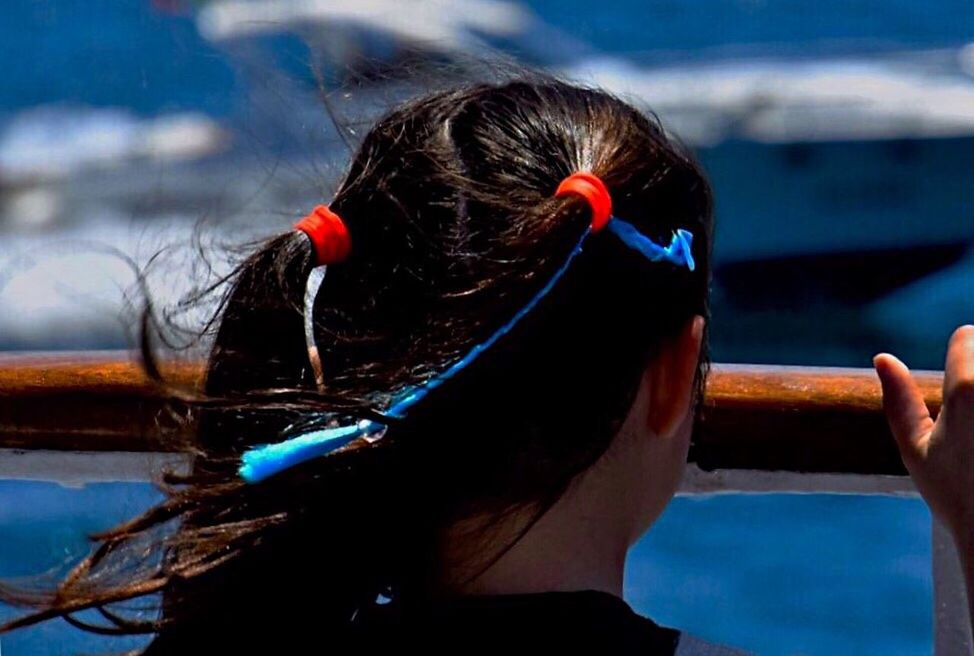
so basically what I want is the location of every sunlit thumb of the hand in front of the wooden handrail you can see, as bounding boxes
[873,353,933,461]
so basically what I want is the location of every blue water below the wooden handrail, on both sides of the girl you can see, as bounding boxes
[0,481,933,656]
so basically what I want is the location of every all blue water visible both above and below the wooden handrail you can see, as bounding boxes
[0,0,974,656]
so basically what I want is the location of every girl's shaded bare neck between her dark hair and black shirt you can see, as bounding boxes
[439,376,692,597]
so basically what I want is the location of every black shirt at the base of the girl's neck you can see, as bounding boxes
[354,590,680,656]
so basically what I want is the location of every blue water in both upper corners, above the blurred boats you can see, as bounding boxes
[0,0,974,115]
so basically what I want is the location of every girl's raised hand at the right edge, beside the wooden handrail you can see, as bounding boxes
[873,326,974,545]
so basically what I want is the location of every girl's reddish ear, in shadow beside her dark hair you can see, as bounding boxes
[645,315,705,438]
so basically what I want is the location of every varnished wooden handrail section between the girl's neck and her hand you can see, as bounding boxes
[691,365,943,475]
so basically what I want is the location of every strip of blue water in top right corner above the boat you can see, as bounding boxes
[526,0,974,59]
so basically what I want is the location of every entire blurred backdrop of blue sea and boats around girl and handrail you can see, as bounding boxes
[0,0,974,656]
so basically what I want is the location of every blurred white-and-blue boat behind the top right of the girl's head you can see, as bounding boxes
[198,0,974,294]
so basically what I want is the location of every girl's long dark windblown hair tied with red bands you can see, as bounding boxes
[0,76,712,654]
